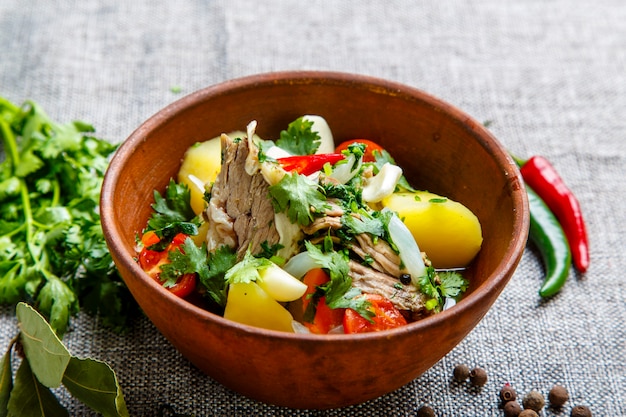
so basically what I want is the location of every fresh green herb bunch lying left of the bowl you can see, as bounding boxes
[0,97,136,336]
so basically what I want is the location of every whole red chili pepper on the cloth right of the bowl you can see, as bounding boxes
[520,156,590,272]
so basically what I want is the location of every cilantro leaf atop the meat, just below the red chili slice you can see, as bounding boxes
[269,173,329,226]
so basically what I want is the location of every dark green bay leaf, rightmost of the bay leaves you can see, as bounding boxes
[63,357,129,417]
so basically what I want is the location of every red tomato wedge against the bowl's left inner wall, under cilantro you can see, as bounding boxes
[139,231,196,298]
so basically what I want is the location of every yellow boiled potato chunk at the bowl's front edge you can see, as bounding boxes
[224,282,294,333]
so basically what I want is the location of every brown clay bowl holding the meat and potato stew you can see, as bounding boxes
[101,72,529,408]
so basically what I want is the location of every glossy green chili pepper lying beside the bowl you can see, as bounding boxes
[526,185,572,297]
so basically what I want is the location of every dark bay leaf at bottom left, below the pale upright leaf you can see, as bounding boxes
[8,361,69,417]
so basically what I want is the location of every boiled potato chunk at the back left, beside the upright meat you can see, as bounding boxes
[178,138,222,214]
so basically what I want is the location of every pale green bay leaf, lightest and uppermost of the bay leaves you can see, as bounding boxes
[16,303,71,388]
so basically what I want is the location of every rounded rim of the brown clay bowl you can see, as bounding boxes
[100,70,530,343]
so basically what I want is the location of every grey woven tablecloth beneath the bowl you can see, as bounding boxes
[0,0,626,417]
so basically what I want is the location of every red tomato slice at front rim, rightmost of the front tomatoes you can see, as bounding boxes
[343,294,407,334]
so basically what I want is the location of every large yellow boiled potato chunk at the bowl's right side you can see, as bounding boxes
[383,191,483,268]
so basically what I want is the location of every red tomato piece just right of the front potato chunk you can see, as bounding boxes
[302,268,345,334]
